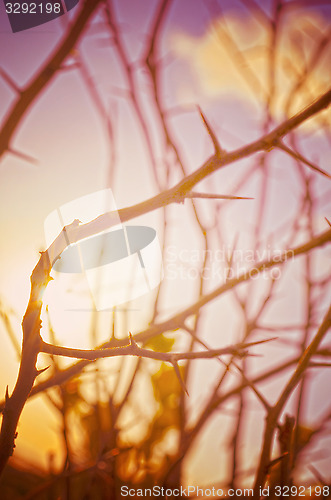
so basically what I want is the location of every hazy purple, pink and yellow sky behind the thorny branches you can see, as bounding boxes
[0,0,331,486]
